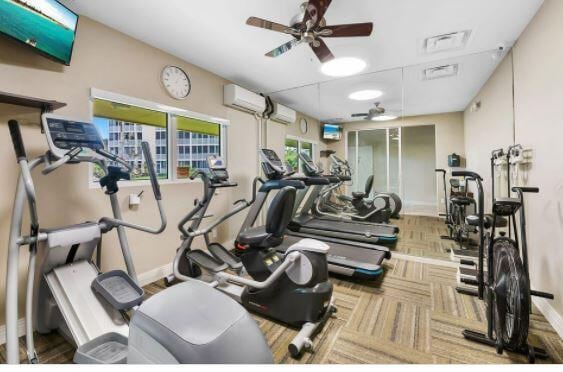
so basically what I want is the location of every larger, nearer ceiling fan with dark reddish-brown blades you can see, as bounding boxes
[246,0,373,63]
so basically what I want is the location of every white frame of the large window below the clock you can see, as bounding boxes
[88,88,231,189]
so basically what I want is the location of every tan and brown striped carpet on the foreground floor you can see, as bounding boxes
[0,217,563,364]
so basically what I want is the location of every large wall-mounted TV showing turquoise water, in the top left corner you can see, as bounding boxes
[0,0,78,66]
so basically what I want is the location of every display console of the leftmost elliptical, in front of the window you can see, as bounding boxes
[41,114,105,160]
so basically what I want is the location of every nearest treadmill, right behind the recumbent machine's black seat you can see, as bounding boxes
[235,149,391,279]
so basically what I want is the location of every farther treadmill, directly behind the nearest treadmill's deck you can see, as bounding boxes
[289,153,399,245]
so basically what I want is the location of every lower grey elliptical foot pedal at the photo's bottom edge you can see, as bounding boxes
[73,333,127,364]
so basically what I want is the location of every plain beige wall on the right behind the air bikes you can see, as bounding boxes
[465,0,563,326]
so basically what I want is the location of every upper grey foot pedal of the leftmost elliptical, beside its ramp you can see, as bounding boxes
[92,270,145,311]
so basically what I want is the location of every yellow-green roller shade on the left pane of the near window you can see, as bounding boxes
[94,99,167,128]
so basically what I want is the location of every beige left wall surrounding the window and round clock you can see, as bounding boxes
[0,17,319,323]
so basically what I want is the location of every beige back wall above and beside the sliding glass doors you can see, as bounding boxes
[328,112,465,209]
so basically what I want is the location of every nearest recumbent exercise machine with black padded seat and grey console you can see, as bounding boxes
[167,156,336,358]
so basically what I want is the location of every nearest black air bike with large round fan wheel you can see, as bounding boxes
[452,171,554,363]
